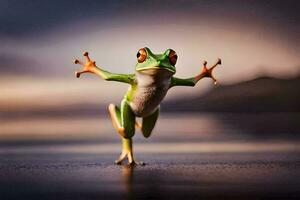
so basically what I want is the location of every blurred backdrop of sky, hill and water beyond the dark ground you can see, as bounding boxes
[0,0,300,147]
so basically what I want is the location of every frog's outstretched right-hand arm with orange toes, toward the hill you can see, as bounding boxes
[170,58,221,87]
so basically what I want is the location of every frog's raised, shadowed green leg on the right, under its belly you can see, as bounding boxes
[140,107,159,138]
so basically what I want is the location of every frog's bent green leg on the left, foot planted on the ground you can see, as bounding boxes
[108,99,143,165]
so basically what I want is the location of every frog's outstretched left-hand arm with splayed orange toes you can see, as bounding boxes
[74,52,134,84]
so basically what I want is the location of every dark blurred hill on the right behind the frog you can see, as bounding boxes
[162,76,300,112]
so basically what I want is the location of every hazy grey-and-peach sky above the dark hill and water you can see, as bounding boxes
[0,0,300,111]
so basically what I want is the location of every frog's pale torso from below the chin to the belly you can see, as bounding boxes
[130,70,171,117]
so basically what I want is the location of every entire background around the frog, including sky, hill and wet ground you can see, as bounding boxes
[0,0,300,200]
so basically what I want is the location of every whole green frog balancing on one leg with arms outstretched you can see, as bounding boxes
[74,47,221,165]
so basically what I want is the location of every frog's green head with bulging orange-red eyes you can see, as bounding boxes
[135,47,177,74]
